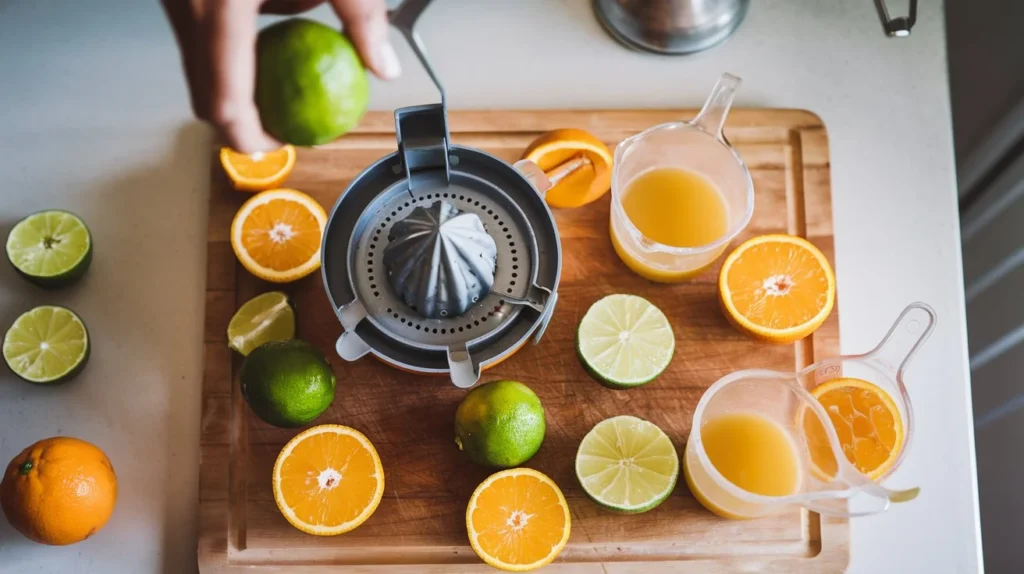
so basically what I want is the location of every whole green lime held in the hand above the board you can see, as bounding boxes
[256,18,369,145]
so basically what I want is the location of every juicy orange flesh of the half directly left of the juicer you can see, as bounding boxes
[242,200,321,271]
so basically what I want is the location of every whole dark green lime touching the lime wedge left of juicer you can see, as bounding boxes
[239,339,335,427]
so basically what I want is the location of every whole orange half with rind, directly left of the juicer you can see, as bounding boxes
[231,188,327,283]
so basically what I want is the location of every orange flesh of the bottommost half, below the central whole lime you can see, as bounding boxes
[470,475,567,565]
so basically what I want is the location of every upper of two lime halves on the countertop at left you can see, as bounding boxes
[7,210,92,288]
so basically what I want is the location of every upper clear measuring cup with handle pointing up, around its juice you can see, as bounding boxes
[610,74,754,282]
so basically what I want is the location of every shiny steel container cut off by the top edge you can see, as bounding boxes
[593,0,750,54]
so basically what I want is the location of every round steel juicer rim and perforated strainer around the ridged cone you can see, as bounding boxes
[322,146,561,386]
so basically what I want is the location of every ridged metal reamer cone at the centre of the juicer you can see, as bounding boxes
[382,198,498,319]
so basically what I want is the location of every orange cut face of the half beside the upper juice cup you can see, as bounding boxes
[728,242,829,329]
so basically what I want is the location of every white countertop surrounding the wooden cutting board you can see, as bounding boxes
[0,0,981,574]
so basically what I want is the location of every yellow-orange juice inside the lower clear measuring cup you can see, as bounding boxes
[683,412,801,519]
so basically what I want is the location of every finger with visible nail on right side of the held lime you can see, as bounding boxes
[331,0,401,80]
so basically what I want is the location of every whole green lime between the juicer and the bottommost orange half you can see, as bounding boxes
[455,381,545,469]
